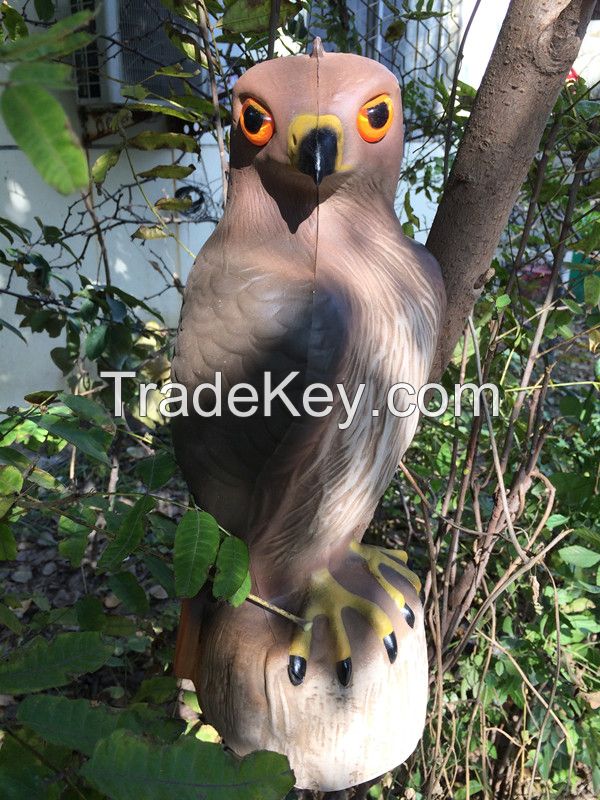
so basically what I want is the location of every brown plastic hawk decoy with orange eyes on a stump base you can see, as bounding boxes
[173,41,445,790]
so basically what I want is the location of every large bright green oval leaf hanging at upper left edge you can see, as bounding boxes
[0,84,89,194]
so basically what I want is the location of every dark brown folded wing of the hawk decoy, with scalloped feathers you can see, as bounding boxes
[173,245,342,540]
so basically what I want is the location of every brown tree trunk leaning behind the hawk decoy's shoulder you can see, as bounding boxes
[427,0,596,380]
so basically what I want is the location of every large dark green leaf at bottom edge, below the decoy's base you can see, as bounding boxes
[81,731,294,800]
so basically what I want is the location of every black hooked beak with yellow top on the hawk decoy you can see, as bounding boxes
[288,114,344,186]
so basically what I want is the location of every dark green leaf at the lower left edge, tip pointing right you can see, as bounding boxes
[0,633,113,694]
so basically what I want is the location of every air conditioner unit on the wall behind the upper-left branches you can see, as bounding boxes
[70,0,203,106]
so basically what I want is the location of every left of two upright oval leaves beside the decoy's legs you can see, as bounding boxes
[173,509,221,597]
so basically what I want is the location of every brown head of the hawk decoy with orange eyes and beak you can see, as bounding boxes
[231,41,403,199]
